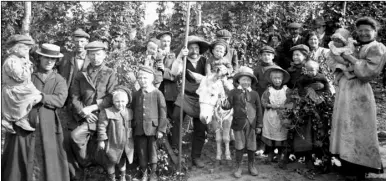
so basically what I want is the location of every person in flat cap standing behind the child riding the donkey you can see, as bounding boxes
[216,29,239,72]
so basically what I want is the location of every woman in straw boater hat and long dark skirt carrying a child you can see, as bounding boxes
[1,44,70,181]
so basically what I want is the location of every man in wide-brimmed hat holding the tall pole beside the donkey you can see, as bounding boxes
[171,36,209,168]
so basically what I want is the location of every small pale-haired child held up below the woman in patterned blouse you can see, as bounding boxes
[297,60,330,103]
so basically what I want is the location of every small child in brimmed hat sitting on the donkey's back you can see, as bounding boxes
[205,39,233,75]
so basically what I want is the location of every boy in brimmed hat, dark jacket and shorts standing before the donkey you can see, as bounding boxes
[222,66,262,178]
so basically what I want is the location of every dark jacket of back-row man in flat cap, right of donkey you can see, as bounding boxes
[277,35,305,70]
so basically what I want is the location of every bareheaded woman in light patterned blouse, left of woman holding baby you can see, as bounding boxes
[305,31,335,94]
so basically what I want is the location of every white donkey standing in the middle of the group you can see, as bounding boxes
[196,67,234,165]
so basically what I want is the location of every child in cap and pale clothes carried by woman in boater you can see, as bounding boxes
[1,35,45,133]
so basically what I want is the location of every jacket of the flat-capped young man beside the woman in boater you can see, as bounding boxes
[69,65,118,130]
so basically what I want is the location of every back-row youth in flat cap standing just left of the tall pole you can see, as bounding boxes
[156,31,178,119]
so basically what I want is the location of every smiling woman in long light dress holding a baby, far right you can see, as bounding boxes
[330,17,386,180]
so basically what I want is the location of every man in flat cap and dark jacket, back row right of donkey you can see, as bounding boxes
[277,23,304,70]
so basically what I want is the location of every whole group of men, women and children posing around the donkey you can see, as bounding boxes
[2,17,386,181]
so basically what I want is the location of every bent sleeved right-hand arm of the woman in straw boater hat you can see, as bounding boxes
[41,74,68,109]
